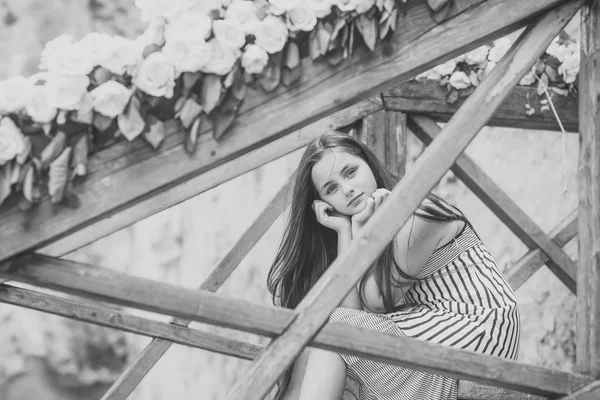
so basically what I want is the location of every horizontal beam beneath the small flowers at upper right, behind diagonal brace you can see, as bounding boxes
[381,80,579,133]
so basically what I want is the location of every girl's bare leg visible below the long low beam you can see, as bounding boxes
[299,348,346,400]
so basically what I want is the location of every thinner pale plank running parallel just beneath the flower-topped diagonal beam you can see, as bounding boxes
[37,98,383,257]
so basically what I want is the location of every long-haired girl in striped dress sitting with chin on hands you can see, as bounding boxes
[267,132,519,400]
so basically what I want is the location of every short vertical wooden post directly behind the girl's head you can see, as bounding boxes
[357,110,408,178]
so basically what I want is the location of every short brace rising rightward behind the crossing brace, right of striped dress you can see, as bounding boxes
[505,211,577,290]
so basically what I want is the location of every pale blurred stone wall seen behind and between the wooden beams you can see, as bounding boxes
[0,0,578,400]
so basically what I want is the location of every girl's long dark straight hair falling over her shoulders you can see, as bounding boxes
[267,132,465,399]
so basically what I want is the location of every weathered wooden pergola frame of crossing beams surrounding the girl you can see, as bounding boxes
[0,0,600,400]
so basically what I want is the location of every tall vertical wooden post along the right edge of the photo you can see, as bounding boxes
[576,0,600,378]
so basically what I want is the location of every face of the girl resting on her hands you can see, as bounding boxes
[311,149,377,215]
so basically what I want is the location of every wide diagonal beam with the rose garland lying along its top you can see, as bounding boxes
[0,0,576,261]
